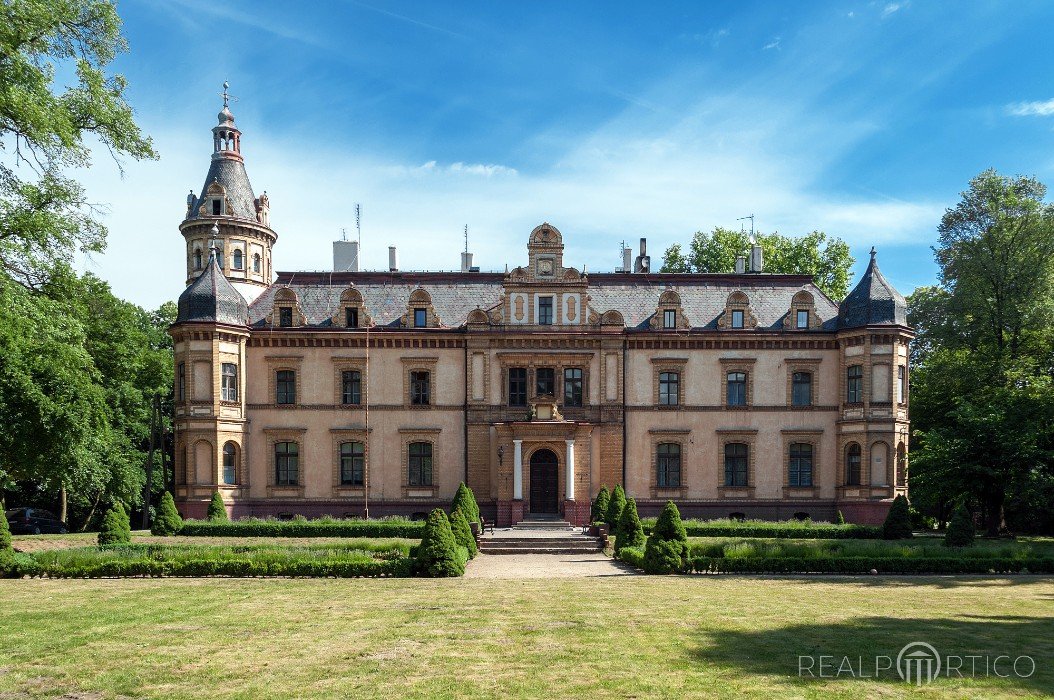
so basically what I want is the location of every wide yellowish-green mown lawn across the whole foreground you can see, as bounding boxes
[0,564,1054,698]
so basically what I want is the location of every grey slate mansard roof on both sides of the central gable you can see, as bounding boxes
[249,272,838,331]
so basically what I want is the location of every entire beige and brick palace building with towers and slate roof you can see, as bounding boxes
[171,92,913,525]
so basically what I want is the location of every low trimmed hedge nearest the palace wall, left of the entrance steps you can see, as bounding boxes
[179,519,425,540]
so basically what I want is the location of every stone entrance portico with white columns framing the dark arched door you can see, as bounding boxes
[493,408,598,527]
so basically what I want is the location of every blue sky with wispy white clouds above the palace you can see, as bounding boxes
[83,0,1054,307]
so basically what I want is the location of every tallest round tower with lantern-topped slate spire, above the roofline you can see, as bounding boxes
[179,82,278,304]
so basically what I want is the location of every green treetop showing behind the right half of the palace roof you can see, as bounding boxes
[660,227,855,299]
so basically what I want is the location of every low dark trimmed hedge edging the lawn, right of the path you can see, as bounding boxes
[691,557,1054,573]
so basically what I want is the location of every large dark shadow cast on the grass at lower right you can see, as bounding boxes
[695,615,1054,694]
